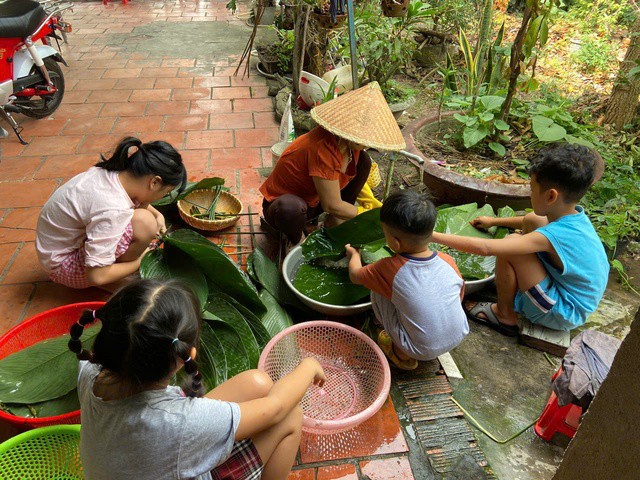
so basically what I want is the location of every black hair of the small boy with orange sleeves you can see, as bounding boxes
[380,190,437,237]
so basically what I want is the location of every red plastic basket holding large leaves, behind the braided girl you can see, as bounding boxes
[0,302,104,431]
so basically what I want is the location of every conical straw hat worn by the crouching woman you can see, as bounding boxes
[311,82,406,150]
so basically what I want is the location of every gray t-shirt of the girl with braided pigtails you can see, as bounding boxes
[78,362,240,480]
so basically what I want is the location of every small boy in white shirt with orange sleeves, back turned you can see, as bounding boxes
[346,190,469,370]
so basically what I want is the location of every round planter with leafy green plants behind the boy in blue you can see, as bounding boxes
[403,2,572,207]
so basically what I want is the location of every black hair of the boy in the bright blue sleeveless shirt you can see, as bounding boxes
[529,142,602,202]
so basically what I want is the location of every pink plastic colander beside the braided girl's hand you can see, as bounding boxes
[258,321,391,434]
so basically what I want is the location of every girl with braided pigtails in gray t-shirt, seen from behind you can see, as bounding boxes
[69,280,325,480]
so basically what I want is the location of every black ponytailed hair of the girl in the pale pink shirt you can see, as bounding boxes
[96,137,187,190]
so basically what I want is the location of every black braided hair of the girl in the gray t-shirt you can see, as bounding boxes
[69,279,204,396]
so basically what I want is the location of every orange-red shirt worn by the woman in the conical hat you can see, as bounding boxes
[260,127,360,207]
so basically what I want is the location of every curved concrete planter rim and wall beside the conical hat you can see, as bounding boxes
[402,114,531,210]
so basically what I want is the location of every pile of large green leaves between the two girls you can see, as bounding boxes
[140,230,292,389]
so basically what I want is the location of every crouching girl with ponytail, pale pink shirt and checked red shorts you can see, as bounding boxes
[36,137,187,288]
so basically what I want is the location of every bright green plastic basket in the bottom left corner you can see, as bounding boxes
[0,425,84,480]
